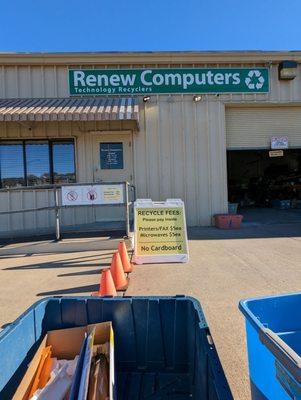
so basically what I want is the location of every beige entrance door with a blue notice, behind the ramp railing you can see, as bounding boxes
[93,133,133,223]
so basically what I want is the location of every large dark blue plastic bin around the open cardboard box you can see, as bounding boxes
[0,296,233,400]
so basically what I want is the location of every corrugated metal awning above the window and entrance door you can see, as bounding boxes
[0,98,139,123]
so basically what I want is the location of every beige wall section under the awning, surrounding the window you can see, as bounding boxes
[0,121,129,237]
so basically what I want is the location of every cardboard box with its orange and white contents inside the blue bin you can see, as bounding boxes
[13,322,116,400]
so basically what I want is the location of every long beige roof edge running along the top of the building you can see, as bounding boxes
[0,50,301,68]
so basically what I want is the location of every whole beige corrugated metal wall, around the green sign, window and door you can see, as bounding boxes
[0,56,301,231]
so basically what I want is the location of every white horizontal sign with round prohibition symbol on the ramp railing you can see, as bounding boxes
[62,184,124,206]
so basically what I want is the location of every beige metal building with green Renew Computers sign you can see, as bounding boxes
[0,52,301,236]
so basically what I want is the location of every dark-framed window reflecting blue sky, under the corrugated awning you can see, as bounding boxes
[0,140,75,187]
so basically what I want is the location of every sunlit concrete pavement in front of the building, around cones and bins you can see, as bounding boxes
[0,224,301,400]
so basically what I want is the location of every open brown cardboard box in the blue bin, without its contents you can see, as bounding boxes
[12,322,116,400]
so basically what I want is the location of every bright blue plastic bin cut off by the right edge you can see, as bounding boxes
[239,293,301,400]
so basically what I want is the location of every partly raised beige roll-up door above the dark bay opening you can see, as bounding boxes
[226,106,301,150]
